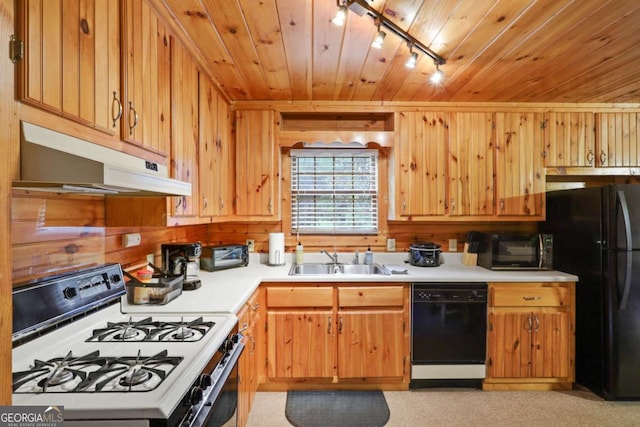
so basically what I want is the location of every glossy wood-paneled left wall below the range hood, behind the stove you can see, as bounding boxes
[11,190,208,286]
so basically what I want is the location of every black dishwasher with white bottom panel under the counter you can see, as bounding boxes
[410,283,487,388]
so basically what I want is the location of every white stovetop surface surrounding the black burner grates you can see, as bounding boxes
[12,305,237,420]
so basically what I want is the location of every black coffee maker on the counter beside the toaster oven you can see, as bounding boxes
[160,242,202,291]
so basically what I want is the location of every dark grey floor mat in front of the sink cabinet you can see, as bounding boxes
[285,390,389,427]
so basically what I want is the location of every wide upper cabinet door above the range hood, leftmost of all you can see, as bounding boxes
[18,0,120,135]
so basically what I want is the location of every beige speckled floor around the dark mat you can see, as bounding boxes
[248,389,640,427]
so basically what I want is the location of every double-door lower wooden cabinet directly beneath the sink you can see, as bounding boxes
[265,283,409,389]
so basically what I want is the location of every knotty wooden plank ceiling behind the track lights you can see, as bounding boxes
[148,0,640,103]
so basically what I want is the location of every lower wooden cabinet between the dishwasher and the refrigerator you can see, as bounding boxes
[483,282,575,390]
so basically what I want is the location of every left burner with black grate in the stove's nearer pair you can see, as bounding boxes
[13,351,107,393]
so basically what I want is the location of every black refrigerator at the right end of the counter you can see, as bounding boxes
[541,184,640,400]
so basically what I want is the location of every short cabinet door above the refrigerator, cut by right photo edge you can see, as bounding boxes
[596,113,640,167]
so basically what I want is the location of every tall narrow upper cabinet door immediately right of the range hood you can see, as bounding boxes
[171,38,200,217]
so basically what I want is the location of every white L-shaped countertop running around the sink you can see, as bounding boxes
[121,252,578,314]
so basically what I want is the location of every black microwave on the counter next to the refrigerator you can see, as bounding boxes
[477,233,553,270]
